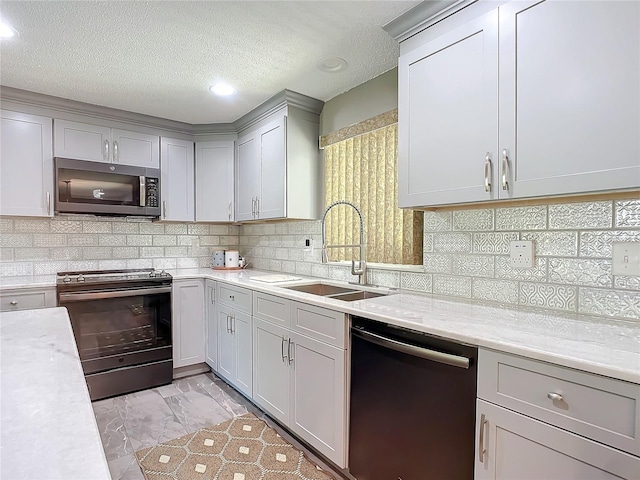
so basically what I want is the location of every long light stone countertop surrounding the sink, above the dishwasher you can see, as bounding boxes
[169,268,640,384]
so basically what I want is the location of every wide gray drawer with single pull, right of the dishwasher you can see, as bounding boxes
[478,350,640,455]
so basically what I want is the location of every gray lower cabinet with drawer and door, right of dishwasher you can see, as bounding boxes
[475,349,640,480]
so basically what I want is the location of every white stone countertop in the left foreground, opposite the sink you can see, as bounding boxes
[0,308,111,480]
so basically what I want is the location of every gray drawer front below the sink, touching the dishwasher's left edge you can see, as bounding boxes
[291,302,347,348]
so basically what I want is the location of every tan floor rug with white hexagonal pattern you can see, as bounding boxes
[136,413,335,480]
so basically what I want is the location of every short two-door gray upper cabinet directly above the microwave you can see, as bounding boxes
[54,119,160,168]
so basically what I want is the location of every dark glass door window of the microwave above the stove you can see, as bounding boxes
[58,170,140,205]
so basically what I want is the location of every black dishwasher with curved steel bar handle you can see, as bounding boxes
[349,317,478,480]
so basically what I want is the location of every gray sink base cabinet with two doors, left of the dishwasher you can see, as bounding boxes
[253,292,347,468]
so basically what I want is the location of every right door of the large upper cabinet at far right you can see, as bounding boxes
[499,0,640,197]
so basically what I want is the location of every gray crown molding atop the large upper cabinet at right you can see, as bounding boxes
[382,0,479,42]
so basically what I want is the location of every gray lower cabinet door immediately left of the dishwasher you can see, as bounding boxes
[289,332,347,468]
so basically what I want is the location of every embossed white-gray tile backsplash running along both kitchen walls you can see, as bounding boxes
[0,195,640,320]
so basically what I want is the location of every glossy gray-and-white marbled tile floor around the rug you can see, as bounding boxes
[93,373,340,480]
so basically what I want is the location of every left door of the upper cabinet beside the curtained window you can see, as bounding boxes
[236,133,262,221]
